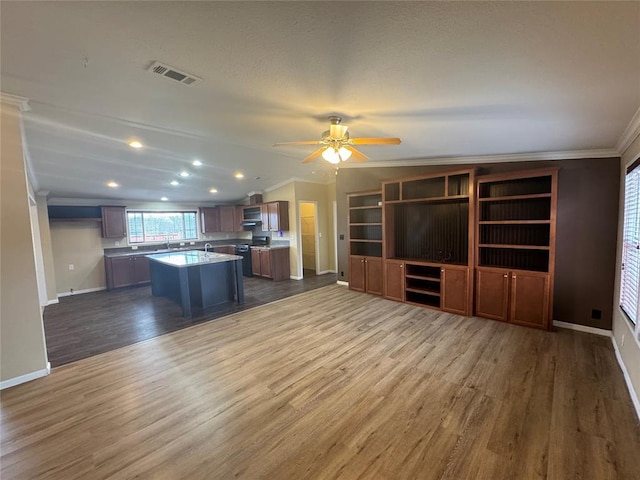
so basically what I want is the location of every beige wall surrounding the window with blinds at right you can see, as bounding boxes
[613,136,640,404]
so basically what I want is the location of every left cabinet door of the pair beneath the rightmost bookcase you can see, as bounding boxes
[476,268,509,322]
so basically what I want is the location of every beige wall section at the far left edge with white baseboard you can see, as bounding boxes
[0,99,47,382]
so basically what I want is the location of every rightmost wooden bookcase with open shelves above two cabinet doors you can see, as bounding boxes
[475,169,557,329]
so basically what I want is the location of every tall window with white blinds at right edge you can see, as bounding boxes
[620,159,640,324]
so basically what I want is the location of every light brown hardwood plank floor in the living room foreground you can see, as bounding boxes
[0,286,640,480]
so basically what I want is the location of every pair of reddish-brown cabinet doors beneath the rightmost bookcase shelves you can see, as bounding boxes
[475,267,551,329]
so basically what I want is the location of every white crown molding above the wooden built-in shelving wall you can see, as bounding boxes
[340,148,620,168]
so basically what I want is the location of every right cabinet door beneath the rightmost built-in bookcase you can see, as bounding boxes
[510,271,549,328]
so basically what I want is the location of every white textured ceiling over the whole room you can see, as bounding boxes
[0,0,640,202]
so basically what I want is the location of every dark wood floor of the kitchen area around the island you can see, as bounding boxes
[44,270,336,367]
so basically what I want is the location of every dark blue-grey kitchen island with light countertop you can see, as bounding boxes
[147,250,244,317]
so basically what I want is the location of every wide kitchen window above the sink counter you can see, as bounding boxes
[127,212,198,243]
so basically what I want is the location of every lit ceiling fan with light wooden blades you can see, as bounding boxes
[273,116,400,164]
